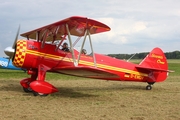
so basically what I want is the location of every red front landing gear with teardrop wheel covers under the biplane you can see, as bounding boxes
[20,64,58,96]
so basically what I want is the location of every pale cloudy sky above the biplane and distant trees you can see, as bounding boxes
[0,0,180,57]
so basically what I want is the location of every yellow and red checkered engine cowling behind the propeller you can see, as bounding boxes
[13,40,26,67]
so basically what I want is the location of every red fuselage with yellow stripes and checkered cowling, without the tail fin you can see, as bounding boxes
[13,40,162,82]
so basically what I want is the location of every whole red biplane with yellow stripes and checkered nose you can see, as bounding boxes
[4,16,170,95]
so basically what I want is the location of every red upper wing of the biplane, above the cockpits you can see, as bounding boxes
[21,16,110,41]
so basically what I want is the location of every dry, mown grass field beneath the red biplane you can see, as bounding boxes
[0,60,180,120]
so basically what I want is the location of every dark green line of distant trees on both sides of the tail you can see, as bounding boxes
[108,51,180,60]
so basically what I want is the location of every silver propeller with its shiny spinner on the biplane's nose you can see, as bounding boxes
[4,25,20,59]
